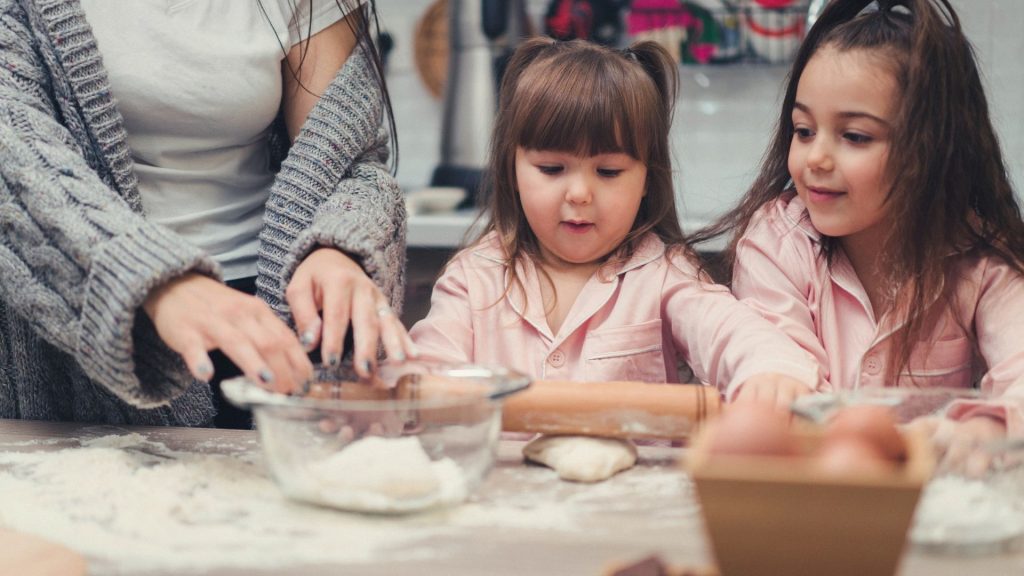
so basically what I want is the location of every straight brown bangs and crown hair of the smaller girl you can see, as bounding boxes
[511,53,657,161]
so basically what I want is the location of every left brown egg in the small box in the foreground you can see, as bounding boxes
[708,404,797,456]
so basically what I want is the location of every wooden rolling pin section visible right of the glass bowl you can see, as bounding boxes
[502,380,722,440]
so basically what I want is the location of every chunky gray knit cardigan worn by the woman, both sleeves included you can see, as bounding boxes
[0,0,406,425]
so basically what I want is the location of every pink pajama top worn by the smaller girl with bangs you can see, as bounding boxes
[411,230,819,395]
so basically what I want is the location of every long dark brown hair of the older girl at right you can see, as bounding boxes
[692,0,1024,378]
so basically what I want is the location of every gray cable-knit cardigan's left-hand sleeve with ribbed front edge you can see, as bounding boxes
[0,0,217,408]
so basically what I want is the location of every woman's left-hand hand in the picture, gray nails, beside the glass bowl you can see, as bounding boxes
[142,273,312,393]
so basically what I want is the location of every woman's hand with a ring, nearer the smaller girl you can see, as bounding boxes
[285,248,416,378]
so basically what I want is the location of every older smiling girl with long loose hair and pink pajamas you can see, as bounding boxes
[694,0,1024,465]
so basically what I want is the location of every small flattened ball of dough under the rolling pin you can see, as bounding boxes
[522,436,637,482]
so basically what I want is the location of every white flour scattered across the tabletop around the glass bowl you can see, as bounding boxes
[0,434,696,576]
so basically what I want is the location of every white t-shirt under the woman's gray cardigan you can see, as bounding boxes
[82,0,345,280]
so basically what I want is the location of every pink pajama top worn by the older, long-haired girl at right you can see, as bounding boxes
[732,194,1024,427]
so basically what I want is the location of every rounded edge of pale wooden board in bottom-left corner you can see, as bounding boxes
[0,528,85,576]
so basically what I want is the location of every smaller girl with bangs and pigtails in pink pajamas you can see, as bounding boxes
[410,38,818,399]
